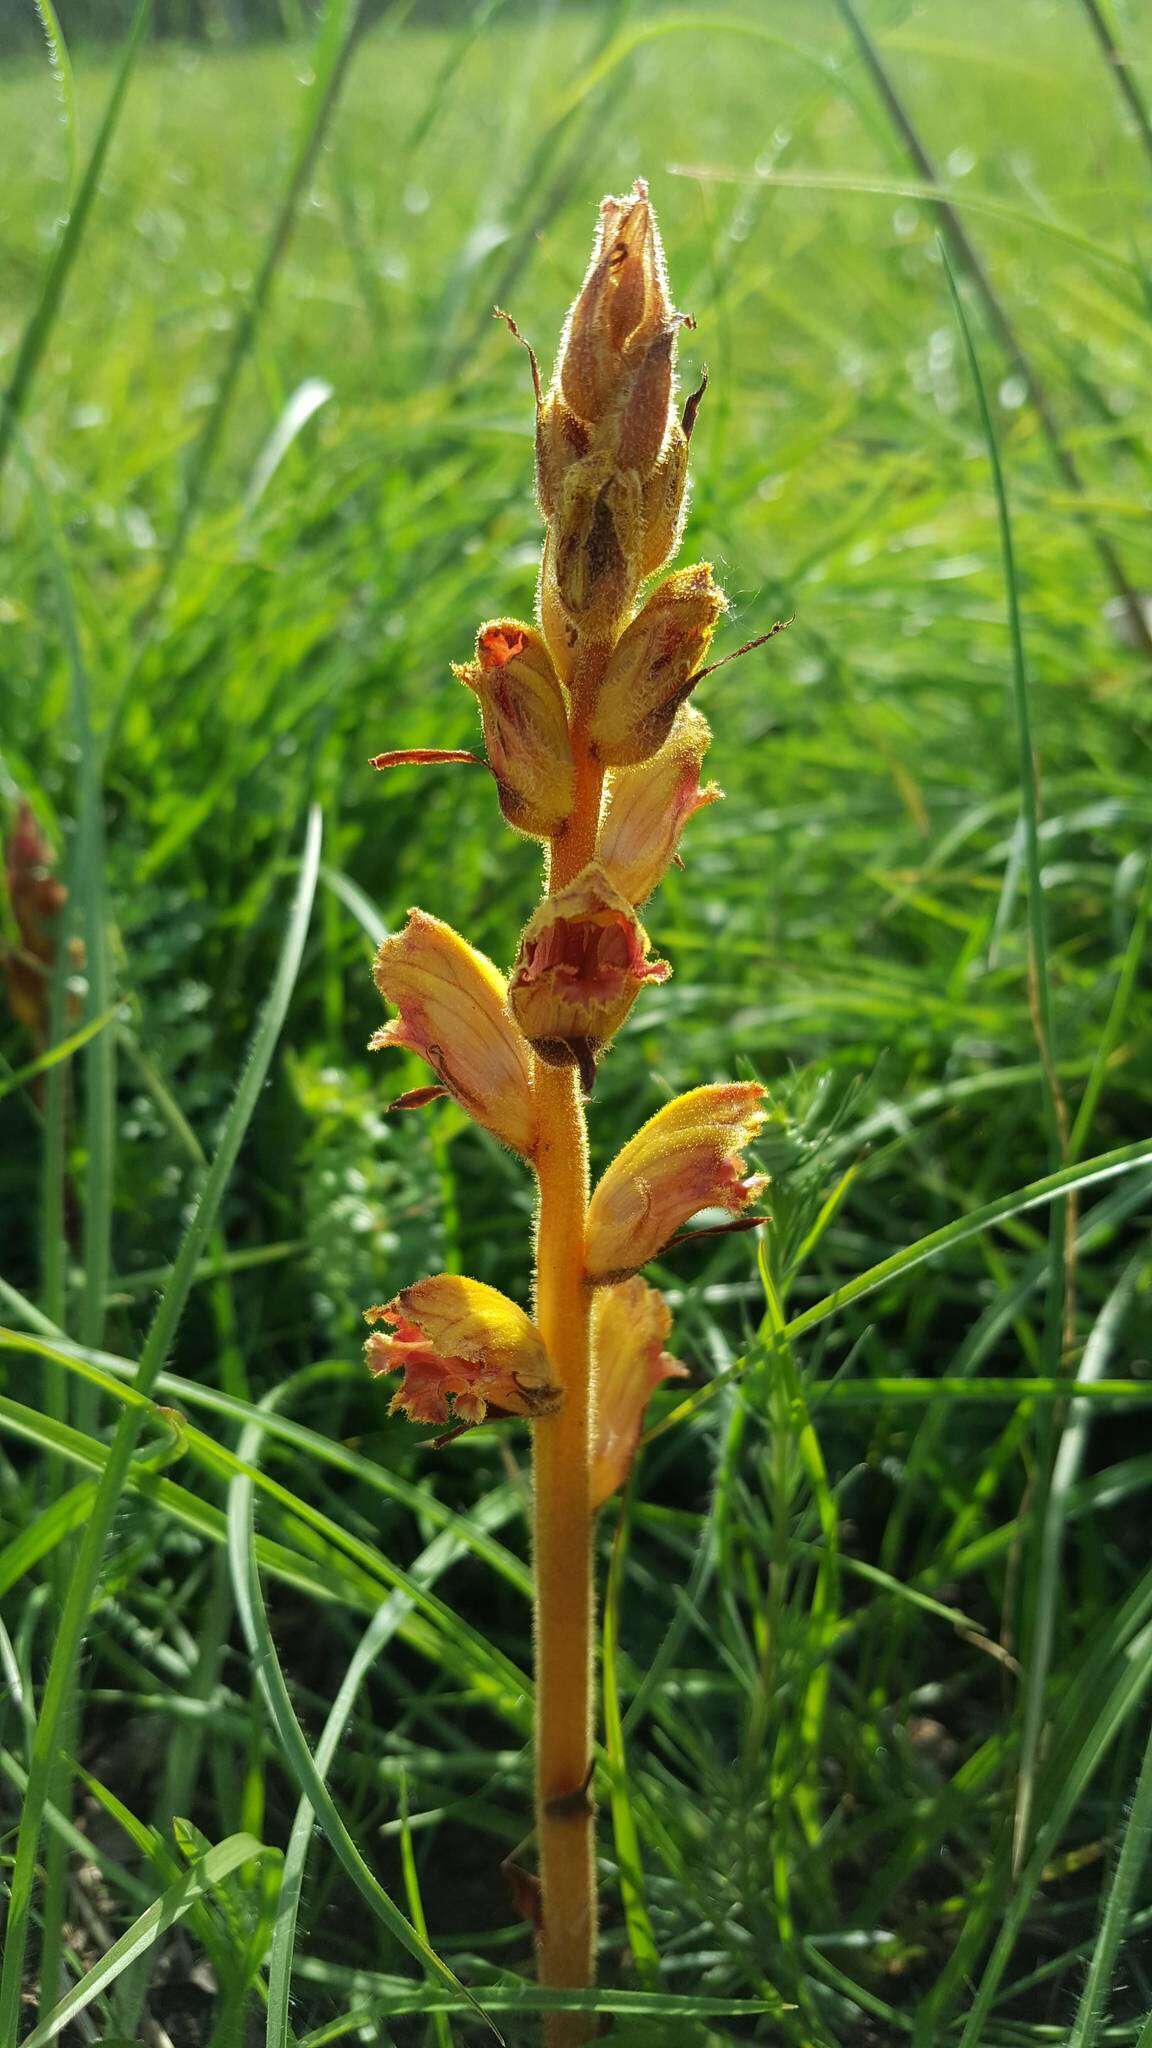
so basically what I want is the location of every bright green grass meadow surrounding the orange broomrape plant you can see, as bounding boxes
[0,0,1152,2048]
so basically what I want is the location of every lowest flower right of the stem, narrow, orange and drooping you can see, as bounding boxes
[592,1276,687,1507]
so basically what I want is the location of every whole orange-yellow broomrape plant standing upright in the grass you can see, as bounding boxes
[367,182,775,2048]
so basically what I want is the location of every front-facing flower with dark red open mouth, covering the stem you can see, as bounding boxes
[510,862,672,1085]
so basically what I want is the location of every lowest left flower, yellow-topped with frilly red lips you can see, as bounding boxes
[365,1274,560,1421]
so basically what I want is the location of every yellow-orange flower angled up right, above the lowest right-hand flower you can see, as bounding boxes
[586,1081,767,1284]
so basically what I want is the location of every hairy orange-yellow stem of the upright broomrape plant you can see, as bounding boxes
[533,649,603,2048]
